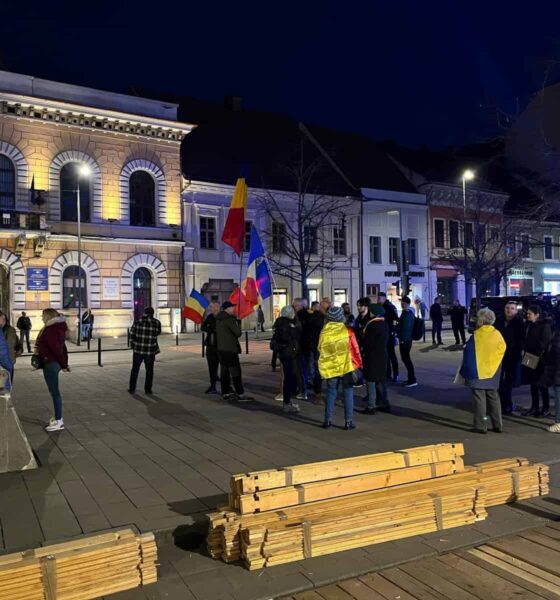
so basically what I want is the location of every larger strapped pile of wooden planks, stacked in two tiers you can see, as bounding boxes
[207,444,548,569]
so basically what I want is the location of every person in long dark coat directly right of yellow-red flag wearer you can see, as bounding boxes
[362,304,389,415]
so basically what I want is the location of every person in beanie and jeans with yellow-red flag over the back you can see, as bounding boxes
[318,306,362,430]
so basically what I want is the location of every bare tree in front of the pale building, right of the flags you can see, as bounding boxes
[257,136,357,298]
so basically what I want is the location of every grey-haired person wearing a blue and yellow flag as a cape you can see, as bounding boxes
[460,308,506,433]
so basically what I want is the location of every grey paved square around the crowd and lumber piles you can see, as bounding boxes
[0,336,560,600]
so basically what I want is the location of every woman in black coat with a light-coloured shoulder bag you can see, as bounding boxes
[521,304,552,417]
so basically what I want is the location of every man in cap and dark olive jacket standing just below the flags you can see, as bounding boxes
[216,300,247,402]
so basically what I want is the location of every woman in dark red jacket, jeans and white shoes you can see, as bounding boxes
[35,308,70,431]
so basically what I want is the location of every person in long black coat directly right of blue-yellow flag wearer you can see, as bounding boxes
[496,302,525,415]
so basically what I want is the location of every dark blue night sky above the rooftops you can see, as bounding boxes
[0,0,560,146]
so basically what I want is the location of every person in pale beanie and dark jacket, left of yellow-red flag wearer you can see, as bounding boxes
[272,306,301,413]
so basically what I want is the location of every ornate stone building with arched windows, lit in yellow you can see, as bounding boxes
[0,72,192,336]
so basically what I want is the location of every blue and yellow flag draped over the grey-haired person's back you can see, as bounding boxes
[460,325,506,381]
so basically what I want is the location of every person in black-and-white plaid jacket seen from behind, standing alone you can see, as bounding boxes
[128,306,161,394]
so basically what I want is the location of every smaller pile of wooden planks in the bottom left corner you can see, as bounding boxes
[0,529,157,600]
